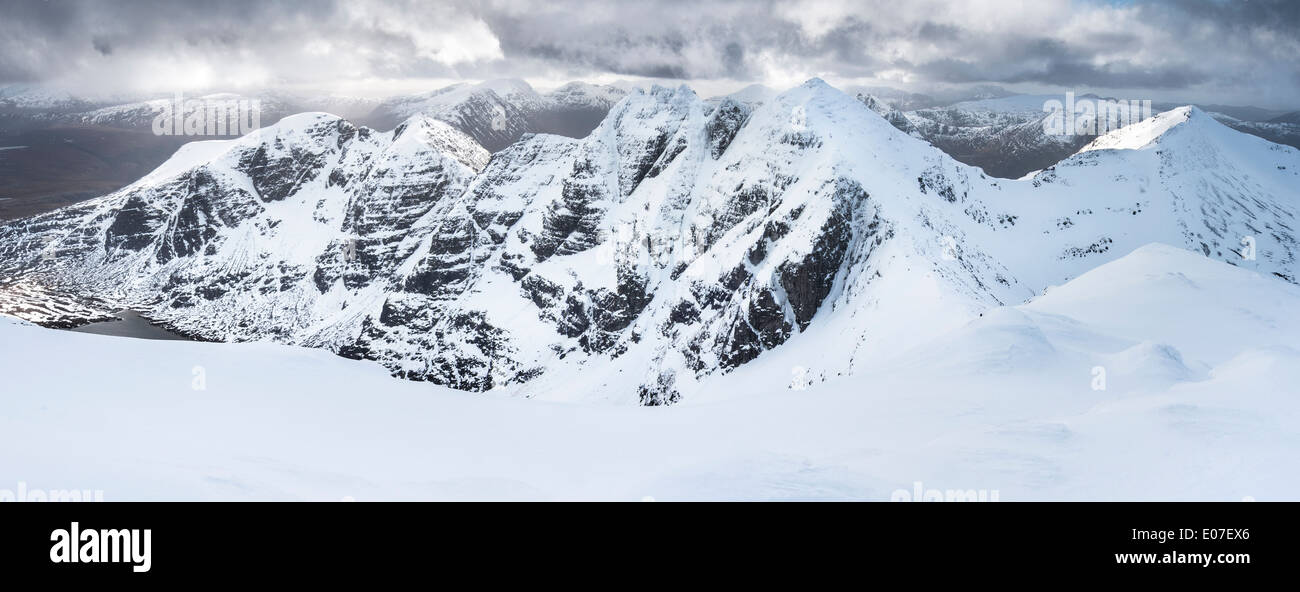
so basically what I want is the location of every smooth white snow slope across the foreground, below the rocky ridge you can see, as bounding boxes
[0,245,1300,501]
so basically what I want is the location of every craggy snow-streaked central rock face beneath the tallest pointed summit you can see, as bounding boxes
[332,81,1030,405]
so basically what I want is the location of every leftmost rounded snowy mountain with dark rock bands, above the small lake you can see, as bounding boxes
[0,113,488,347]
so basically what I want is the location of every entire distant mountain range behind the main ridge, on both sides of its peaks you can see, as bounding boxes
[0,79,1300,220]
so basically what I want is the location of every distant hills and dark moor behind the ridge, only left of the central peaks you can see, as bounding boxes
[0,81,624,220]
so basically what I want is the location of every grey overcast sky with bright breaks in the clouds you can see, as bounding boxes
[0,0,1300,109]
